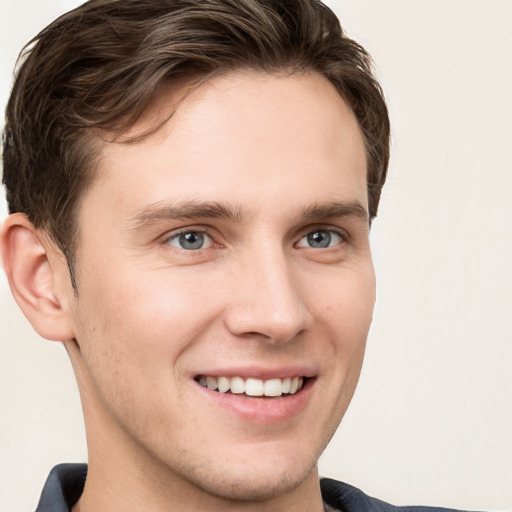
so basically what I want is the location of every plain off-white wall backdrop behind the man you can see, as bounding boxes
[0,0,512,512]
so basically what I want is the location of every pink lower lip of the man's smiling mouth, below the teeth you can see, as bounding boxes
[195,378,316,424]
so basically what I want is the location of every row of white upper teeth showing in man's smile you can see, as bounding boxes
[198,375,304,396]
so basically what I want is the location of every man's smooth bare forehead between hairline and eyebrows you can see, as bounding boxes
[88,72,367,222]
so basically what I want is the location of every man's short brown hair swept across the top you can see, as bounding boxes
[3,0,389,286]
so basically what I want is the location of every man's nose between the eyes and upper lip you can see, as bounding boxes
[226,244,313,344]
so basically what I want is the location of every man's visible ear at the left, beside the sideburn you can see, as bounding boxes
[0,213,74,341]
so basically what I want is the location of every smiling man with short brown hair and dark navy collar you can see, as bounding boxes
[2,0,460,512]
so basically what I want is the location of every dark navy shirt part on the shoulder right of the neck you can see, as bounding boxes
[320,478,472,512]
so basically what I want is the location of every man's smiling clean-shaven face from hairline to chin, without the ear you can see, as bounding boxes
[66,73,374,499]
